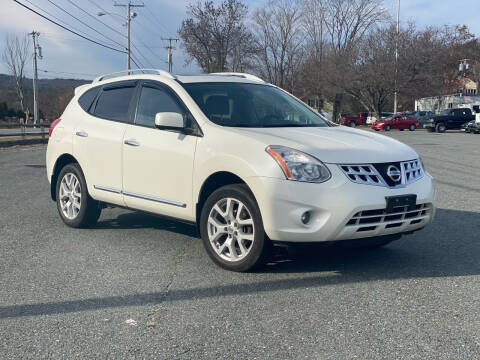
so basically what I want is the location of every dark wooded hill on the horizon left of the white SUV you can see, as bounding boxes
[0,74,91,120]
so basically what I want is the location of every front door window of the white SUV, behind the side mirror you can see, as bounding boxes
[135,86,185,127]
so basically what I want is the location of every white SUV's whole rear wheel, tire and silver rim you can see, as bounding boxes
[56,164,102,228]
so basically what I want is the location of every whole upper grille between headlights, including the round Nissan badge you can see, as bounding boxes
[339,159,424,188]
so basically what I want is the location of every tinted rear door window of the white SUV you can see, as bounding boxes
[94,86,135,121]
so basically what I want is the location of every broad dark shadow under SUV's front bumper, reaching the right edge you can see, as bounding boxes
[259,209,480,281]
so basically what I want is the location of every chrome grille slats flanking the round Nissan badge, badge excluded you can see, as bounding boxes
[338,159,424,189]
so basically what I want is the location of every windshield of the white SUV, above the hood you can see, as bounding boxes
[183,82,329,127]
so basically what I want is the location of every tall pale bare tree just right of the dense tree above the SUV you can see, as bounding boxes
[253,0,304,91]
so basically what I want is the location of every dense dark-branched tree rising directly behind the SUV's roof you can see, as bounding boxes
[178,0,255,73]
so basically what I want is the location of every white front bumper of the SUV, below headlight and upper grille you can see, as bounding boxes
[247,164,435,242]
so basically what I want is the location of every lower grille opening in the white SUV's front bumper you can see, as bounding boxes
[346,204,432,232]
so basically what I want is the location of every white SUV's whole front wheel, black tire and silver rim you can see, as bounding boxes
[200,184,270,271]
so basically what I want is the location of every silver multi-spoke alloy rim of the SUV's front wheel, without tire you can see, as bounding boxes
[207,198,255,262]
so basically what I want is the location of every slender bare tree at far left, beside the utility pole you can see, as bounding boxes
[2,35,31,121]
